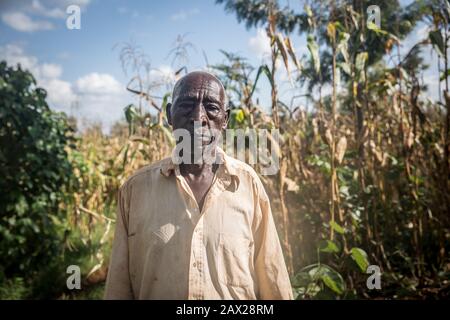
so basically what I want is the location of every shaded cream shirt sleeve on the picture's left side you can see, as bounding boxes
[104,185,134,300]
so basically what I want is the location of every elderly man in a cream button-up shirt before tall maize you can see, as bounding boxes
[105,72,292,299]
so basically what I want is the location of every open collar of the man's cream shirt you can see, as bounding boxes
[160,147,239,190]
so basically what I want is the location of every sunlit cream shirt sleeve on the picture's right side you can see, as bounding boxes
[254,181,293,300]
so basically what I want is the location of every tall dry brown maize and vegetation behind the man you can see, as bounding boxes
[0,0,450,299]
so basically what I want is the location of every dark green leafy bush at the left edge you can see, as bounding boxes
[0,62,73,288]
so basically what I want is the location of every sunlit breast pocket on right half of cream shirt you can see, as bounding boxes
[217,233,253,287]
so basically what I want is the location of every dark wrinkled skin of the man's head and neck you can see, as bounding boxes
[167,71,229,210]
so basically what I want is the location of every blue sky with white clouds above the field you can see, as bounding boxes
[0,0,442,129]
